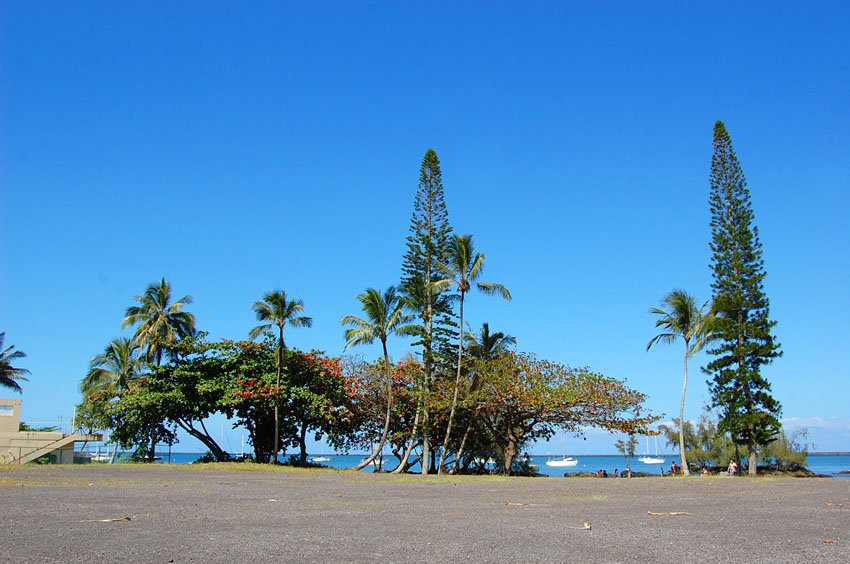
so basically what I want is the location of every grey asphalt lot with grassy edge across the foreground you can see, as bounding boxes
[0,464,850,563]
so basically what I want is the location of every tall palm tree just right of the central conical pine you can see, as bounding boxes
[432,235,511,474]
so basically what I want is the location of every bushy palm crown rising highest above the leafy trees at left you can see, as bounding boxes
[121,278,195,366]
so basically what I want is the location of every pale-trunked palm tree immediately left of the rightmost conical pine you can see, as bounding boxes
[646,289,714,476]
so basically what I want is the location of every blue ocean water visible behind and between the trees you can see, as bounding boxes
[121,451,850,478]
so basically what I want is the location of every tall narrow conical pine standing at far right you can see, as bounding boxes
[704,121,782,472]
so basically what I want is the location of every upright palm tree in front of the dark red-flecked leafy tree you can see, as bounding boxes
[248,290,313,464]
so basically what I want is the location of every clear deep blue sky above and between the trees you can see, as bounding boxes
[0,1,850,454]
